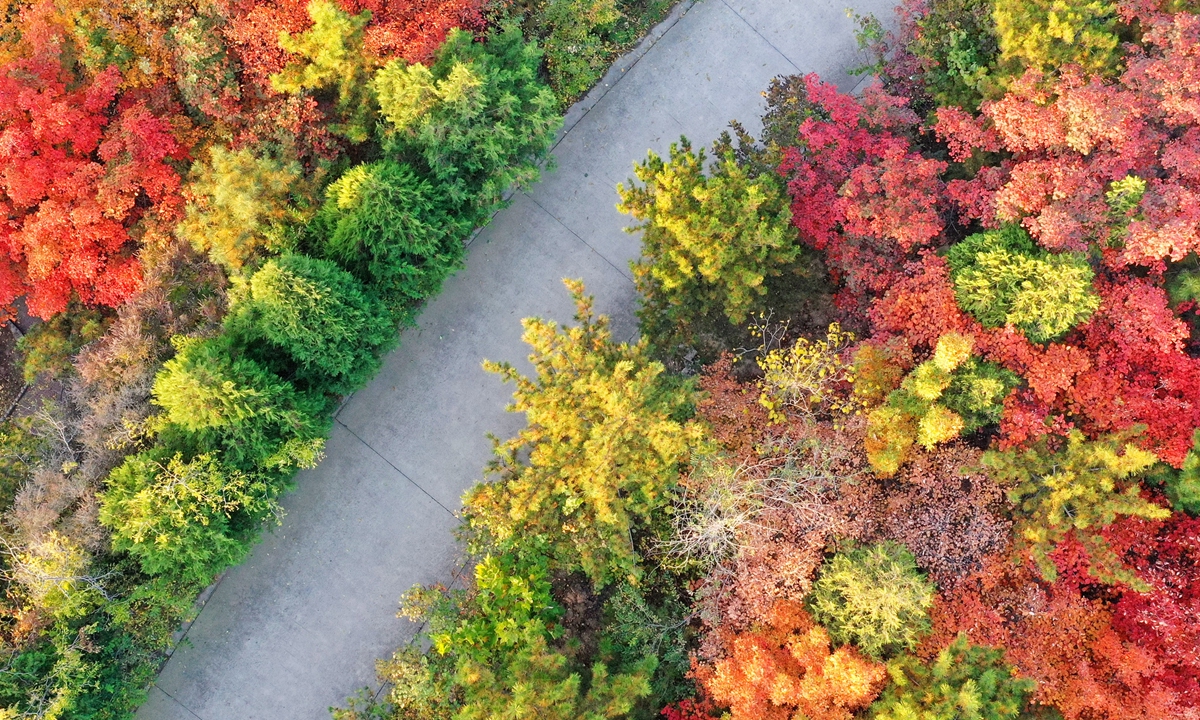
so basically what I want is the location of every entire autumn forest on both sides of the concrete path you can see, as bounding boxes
[0,0,1200,720]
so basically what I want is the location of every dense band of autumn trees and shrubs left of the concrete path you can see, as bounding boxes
[0,0,670,719]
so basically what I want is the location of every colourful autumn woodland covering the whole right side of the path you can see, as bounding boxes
[335,0,1200,720]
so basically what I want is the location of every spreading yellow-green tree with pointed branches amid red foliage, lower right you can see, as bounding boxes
[984,431,1171,587]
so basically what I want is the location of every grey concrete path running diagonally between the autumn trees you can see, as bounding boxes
[138,0,892,720]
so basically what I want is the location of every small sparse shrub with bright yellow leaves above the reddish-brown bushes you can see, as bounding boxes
[757,323,862,422]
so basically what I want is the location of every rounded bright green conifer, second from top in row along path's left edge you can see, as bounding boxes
[310,161,472,319]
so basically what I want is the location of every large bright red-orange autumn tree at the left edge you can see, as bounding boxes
[0,11,187,318]
